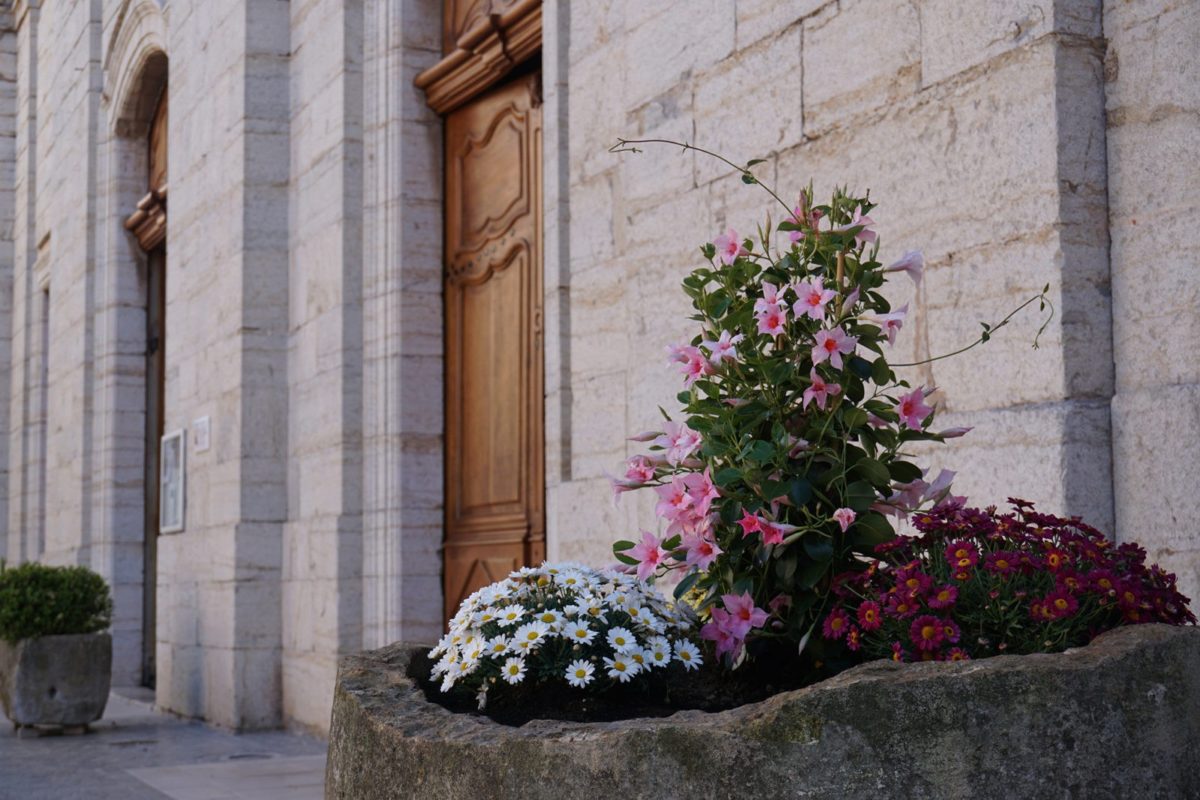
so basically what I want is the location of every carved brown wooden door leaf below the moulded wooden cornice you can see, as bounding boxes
[444,74,545,616]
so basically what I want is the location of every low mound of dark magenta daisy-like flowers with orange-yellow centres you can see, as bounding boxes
[823,500,1195,661]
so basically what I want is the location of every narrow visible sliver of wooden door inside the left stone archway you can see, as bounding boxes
[125,85,167,686]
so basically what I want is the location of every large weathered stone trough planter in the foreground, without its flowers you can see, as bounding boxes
[325,625,1200,800]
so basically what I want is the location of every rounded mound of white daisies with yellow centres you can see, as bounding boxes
[430,563,701,692]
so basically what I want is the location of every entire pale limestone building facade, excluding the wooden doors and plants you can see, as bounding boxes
[0,0,1200,729]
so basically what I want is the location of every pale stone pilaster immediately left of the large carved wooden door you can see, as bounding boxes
[362,0,443,648]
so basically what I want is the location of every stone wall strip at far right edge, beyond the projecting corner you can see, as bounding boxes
[1104,0,1200,602]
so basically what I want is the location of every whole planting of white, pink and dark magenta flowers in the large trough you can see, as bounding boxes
[431,142,1194,724]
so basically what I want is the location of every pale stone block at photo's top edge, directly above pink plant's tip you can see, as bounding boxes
[803,0,920,136]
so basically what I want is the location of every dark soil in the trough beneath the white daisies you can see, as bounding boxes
[409,651,832,726]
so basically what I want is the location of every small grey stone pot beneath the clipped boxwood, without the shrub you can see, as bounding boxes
[0,633,113,727]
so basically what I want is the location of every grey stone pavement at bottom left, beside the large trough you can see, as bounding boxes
[0,690,325,800]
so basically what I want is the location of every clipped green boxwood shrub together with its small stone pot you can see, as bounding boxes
[0,563,113,728]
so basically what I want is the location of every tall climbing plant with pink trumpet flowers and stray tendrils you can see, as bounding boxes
[613,140,1049,663]
